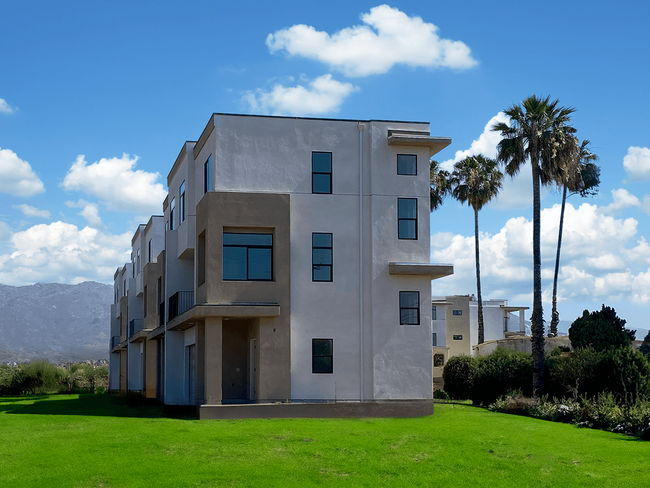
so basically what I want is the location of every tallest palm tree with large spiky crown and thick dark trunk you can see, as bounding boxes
[492,95,577,396]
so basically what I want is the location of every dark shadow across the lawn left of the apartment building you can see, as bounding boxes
[0,394,196,419]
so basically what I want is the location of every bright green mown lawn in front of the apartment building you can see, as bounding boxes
[0,395,650,488]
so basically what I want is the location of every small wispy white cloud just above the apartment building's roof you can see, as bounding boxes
[242,74,358,115]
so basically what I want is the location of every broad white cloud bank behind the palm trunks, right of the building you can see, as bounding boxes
[431,203,650,305]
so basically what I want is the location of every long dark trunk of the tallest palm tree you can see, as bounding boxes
[530,160,544,398]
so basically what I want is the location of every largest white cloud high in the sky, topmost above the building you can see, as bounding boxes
[266,5,478,77]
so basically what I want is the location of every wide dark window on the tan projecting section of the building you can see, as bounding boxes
[223,232,273,281]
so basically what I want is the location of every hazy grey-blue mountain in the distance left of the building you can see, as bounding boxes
[0,281,113,363]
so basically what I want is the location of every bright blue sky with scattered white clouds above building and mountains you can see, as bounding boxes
[0,0,650,338]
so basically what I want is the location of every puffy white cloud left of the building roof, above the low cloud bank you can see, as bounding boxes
[62,154,167,213]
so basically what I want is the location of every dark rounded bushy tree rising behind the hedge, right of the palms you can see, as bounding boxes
[569,304,636,351]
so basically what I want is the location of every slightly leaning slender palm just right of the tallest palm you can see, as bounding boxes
[549,139,600,337]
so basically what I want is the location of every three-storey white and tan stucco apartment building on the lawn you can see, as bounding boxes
[110,114,453,418]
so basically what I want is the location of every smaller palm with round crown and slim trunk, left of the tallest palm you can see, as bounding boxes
[449,154,503,344]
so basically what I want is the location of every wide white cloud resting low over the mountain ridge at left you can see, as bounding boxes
[0,222,131,285]
